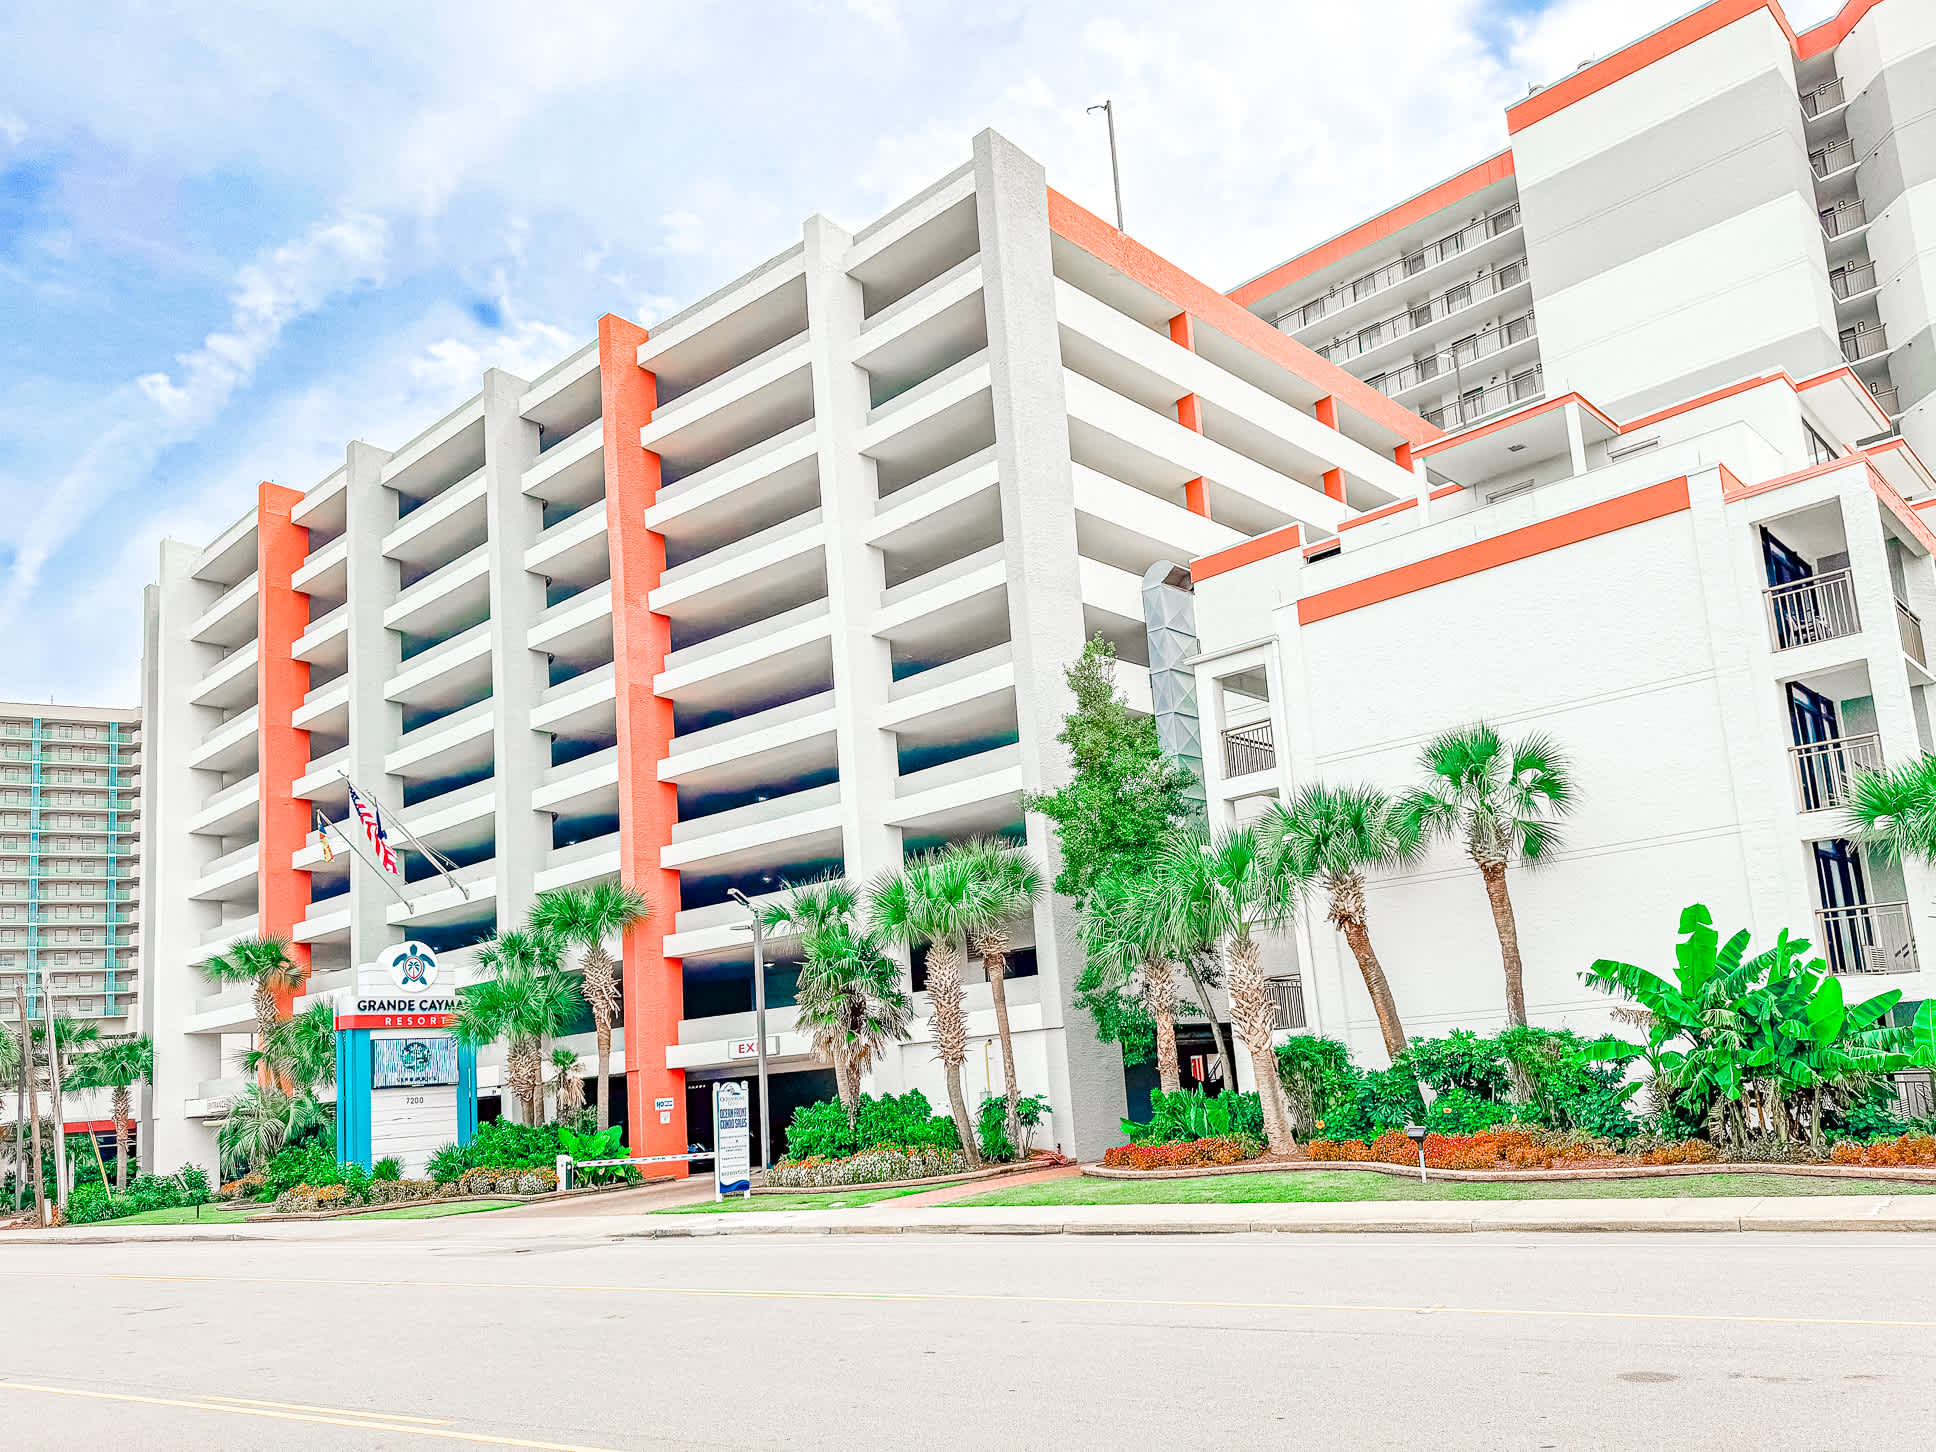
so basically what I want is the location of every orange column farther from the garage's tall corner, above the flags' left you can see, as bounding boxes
[256,482,310,1018]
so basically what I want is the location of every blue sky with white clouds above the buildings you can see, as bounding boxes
[0,0,1831,705]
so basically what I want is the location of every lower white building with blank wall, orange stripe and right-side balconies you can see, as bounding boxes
[1193,368,1936,1067]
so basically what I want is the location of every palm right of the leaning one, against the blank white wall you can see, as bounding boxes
[1400,720,1574,1024]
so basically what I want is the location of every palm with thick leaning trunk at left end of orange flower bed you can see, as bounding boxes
[1152,827,1297,1154]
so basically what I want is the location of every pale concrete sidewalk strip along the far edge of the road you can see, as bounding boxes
[11,1195,1936,1255]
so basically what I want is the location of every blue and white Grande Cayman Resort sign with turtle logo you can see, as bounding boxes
[337,943,476,1177]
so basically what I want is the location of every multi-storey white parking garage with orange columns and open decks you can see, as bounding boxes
[143,132,1438,1164]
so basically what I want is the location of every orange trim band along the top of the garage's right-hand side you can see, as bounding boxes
[1049,186,1442,443]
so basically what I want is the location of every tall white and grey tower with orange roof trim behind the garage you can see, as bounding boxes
[1231,0,1936,474]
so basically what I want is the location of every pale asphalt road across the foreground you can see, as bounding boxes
[0,1222,1936,1452]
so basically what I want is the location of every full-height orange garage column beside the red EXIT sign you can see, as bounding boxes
[598,314,687,1177]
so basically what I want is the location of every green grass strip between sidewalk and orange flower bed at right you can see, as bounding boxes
[949,1169,1936,1210]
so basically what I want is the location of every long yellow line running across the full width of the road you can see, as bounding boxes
[11,1270,1936,1330]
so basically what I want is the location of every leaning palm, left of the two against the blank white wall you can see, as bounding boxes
[1258,782,1419,1063]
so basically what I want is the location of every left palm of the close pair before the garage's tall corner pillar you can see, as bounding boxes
[867,848,989,1167]
